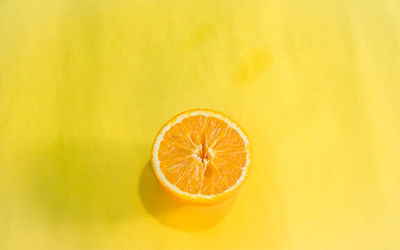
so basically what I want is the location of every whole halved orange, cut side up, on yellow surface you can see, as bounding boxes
[152,109,250,205]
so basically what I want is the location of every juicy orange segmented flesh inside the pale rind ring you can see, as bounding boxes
[158,115,246,195]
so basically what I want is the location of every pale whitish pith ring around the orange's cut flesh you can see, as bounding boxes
[152,110,250,199]
